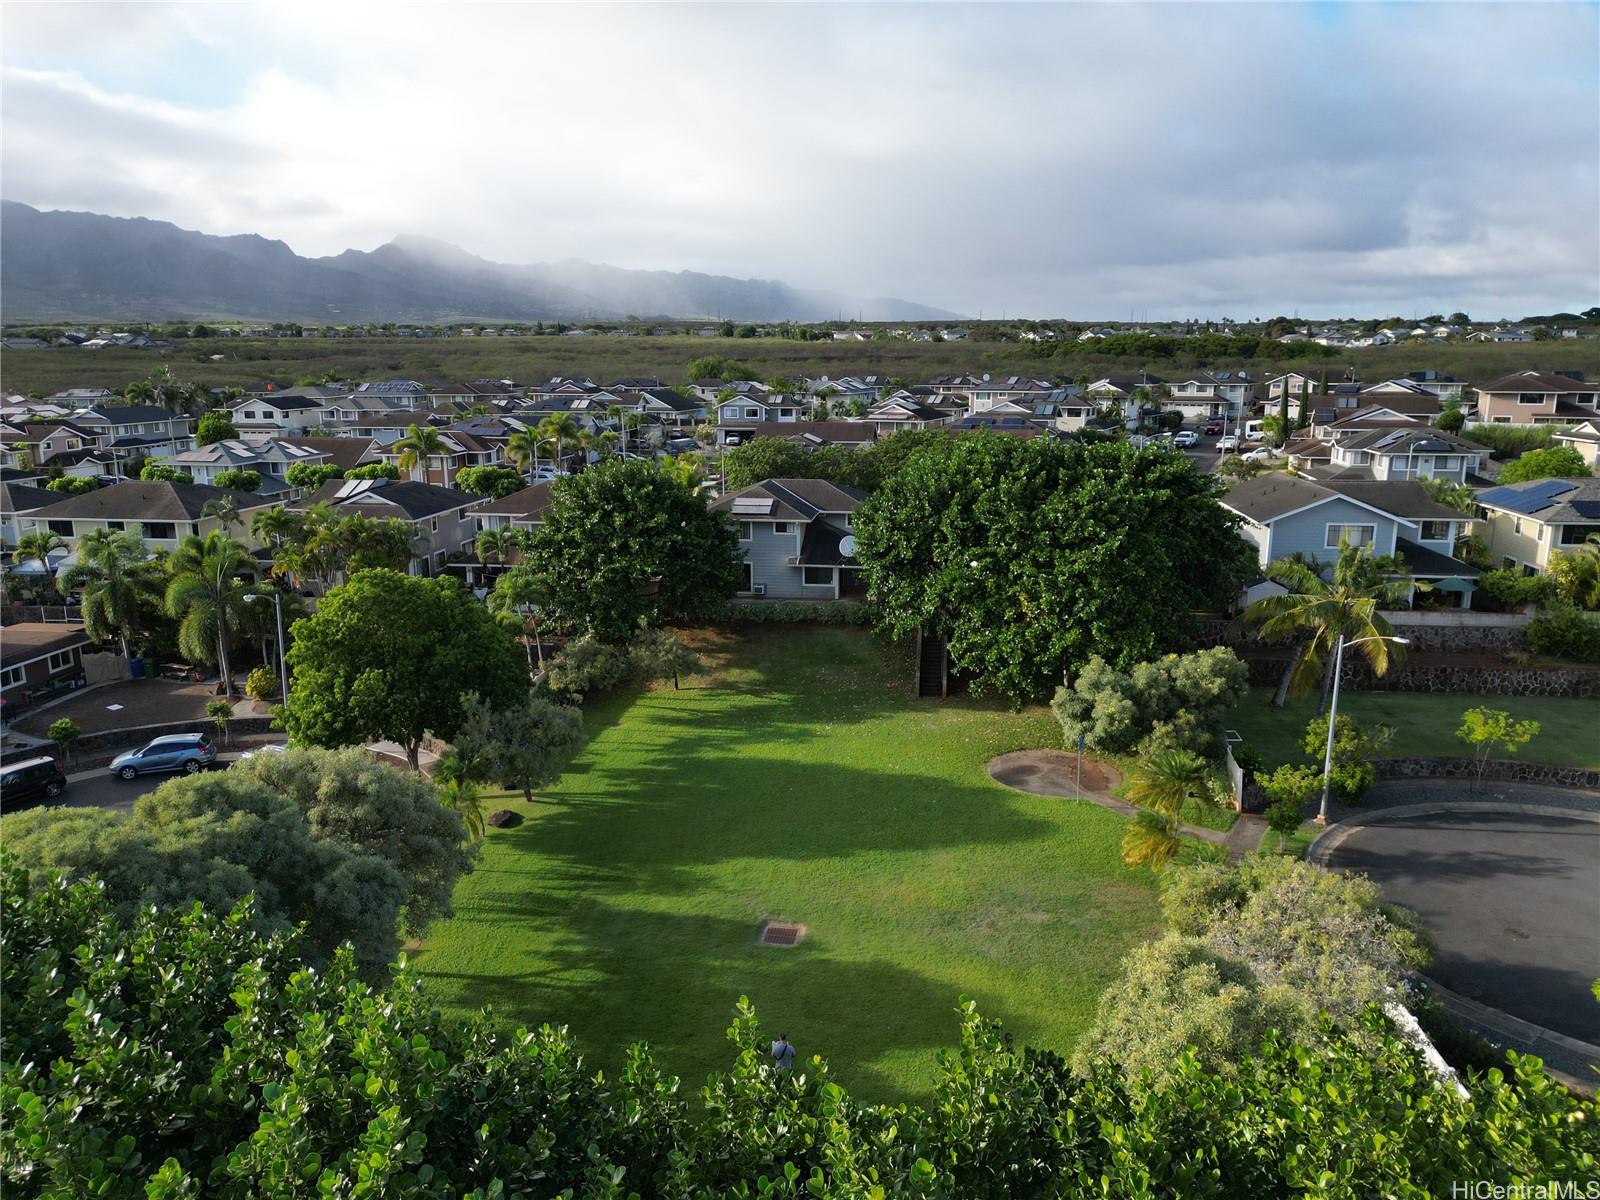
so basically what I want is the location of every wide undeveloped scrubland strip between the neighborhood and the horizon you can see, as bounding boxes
[0,336,1600,395]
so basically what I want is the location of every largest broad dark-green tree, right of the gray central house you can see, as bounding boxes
[854,434,1253,702]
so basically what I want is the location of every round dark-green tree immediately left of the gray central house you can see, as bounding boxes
[526,461,744,642]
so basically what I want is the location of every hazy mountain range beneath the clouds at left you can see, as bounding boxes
[0,200,957,325]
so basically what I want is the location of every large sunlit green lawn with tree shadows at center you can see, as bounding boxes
[414,629,1160,1099]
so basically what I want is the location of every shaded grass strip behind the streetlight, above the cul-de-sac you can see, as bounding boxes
[1227,688,1600,768]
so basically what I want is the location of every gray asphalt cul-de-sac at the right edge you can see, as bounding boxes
[1330,810,1600,1042]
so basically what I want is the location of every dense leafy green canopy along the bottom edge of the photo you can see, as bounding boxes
[0,858,1600,1200]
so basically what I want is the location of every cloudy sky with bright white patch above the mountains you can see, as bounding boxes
[0,0,1600,322]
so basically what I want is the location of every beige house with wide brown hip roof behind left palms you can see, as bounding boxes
[19,480,277,550]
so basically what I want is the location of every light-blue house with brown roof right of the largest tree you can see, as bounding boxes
[1221,472,1480,608]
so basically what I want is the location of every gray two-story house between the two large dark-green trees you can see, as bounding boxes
[710,478,866,600]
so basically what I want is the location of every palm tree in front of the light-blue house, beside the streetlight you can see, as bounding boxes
[1245,541,1413,715]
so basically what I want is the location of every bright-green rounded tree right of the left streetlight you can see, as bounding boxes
[283,568,528,770]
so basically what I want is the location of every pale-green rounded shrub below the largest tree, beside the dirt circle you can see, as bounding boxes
[1051,646,1250,754]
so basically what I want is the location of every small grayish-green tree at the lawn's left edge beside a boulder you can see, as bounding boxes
[456,691,584,803]
